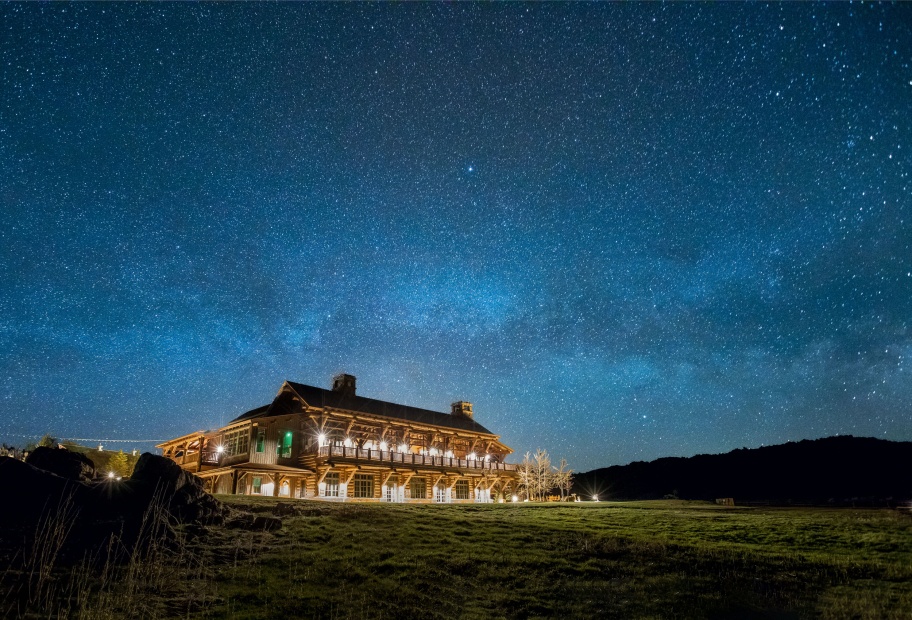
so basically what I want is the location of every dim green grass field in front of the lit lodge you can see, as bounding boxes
[3,497,912,619]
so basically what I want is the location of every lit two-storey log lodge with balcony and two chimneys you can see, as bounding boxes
[156,374,518,503]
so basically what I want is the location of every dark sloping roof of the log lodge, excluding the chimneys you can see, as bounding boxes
[232,381,494,435]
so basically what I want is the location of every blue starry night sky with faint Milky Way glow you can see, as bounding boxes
[0,3,912,470]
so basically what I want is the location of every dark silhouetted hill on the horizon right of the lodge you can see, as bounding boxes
[573,435,912,505]
